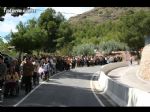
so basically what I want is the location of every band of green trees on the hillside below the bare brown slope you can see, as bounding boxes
[70,10,150,51]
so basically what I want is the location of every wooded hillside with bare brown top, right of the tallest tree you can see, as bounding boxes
[68,7,150,55]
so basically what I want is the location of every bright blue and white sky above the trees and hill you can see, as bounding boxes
[0,7,94,40]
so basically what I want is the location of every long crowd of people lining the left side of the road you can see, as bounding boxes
[0,52,122,100]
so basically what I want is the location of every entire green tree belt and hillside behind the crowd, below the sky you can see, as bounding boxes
[1,7,150,55]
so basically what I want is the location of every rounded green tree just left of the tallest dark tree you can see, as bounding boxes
[11,18,47,52]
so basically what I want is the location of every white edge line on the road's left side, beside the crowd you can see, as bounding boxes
[13,71,65,107]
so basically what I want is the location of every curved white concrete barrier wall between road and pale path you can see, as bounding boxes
[98,62,150,106]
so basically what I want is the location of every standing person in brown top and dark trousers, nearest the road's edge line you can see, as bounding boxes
[23,57,34,94]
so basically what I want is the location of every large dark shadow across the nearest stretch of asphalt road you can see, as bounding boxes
[16,84,100,107]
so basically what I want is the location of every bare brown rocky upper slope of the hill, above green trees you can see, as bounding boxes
[69,7,150,24]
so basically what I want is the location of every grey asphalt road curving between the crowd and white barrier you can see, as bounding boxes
[4,66,117,107]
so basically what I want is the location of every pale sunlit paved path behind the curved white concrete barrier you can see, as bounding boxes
[108,64,150,92]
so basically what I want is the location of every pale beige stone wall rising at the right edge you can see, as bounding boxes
[137,44,150,80]
